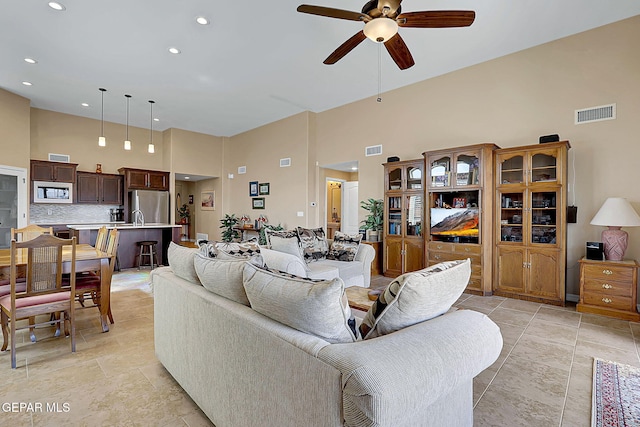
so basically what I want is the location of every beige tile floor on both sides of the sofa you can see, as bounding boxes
[0,270,640,427]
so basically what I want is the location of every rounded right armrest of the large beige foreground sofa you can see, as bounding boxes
[319,310,502,426]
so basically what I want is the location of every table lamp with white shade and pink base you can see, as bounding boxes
[591,197,640,261]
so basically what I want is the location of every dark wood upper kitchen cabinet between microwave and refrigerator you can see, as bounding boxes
[76,172,124,205]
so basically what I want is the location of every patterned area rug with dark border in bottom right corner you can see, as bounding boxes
[591,358,640,427]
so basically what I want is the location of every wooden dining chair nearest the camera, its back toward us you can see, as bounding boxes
[0,234,76,369]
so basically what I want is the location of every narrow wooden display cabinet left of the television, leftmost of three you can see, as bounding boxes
[382,159,424,277]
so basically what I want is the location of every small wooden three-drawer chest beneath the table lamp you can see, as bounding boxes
[576,258,640,322]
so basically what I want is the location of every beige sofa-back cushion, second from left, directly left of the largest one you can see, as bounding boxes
[193,253,249,306]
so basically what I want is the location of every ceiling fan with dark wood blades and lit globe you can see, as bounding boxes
[297,0,476,70]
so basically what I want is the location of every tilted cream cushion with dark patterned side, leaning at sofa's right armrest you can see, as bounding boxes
[360,259,471,339]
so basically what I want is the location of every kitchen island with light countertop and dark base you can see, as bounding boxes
[67,226,181,269]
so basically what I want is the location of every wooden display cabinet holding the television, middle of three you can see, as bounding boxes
[423,143,498,295]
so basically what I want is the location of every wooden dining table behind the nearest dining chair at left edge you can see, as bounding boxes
[0,244,112,332]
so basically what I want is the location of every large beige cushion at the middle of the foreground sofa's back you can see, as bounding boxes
[243,263,357,343]
